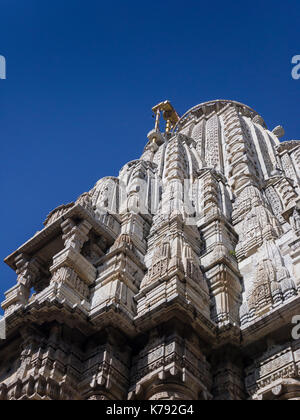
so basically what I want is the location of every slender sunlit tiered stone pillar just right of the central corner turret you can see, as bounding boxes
[199,171,242,326]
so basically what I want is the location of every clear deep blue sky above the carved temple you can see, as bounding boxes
[0,0,300,308]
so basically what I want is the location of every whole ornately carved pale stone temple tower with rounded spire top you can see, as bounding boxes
[0,100,300,400]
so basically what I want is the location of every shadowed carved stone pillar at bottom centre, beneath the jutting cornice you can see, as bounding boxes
[129,322,212,400]
